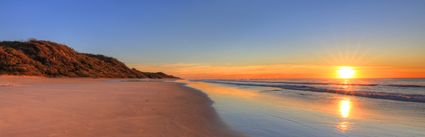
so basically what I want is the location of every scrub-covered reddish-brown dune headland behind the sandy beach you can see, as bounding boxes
[0,39,178,78]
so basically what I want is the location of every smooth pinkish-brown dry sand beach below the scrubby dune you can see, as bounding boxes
[0,77,240,137]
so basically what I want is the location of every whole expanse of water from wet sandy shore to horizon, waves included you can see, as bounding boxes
[185,79,425,137]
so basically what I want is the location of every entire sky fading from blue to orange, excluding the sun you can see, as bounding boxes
[0,0,425,78]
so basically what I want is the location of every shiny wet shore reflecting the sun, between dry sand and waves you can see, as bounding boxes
[184,81,425,137]
